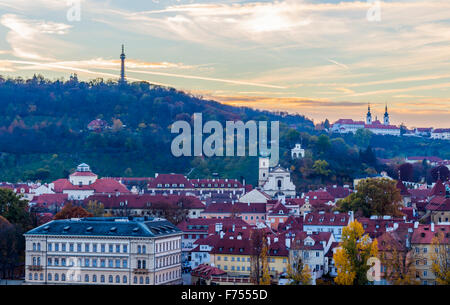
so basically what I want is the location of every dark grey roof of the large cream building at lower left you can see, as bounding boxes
[24,217,182,237]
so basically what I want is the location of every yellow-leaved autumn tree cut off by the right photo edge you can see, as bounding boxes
[431,232,450,285]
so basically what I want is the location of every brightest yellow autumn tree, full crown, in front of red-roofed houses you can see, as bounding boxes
[333,220,378,285]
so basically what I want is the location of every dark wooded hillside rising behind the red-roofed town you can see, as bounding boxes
[0,76,450,186]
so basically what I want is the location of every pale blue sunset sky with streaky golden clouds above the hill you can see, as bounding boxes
[0,0,450,128]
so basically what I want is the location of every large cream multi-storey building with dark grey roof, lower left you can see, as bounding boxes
[24,217,182,285]
